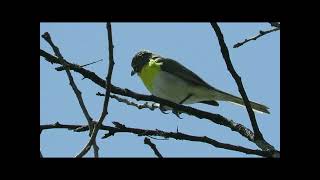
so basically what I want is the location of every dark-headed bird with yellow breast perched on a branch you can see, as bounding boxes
[131,50,270,114]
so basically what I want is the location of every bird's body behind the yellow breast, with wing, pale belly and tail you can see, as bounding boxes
[152,58,270,113]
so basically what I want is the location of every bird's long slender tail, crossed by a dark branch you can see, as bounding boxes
[215,90,270,114]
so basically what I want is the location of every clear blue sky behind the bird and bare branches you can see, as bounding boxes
[39,23,280,157]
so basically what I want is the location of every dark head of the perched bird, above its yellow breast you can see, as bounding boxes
[131,50,154,76]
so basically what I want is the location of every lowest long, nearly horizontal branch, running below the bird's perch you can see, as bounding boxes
[40,122,278,157]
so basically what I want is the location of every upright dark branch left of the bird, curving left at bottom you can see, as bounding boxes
[76,22,114,158]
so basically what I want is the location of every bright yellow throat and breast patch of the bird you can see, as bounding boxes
[138,60,162,92]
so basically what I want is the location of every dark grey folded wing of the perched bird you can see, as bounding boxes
[158,58,214,89]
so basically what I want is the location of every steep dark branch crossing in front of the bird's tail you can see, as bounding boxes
[211,22,274,150]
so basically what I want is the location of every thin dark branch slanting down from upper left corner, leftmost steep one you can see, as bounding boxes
[41,32,99,157]
